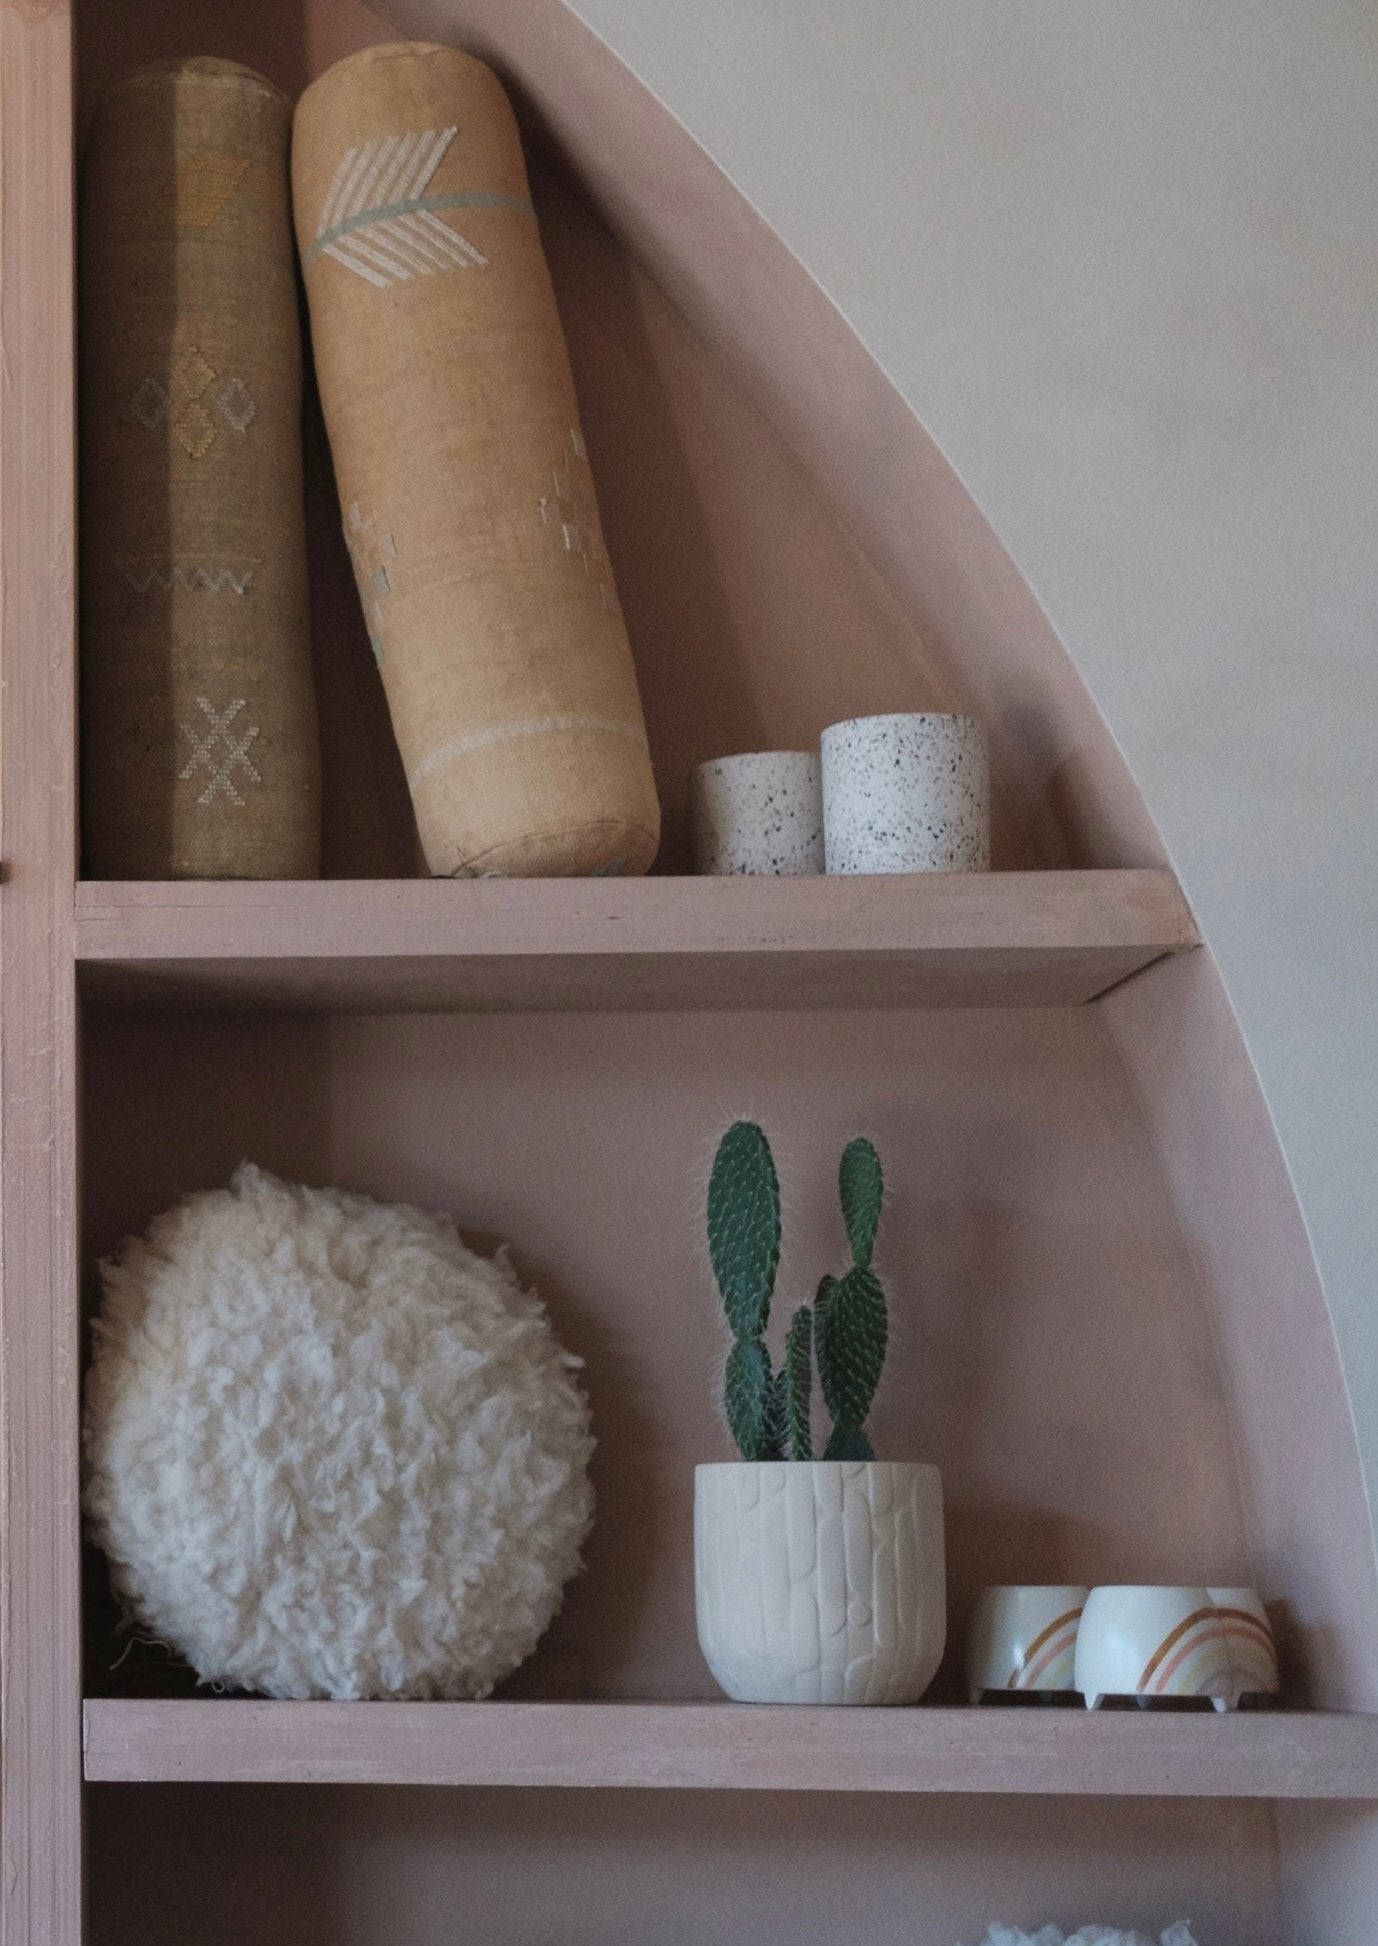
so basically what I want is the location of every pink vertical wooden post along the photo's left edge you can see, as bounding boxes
[0,0,82,1946]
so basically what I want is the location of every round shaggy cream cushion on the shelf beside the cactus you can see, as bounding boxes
[86,1164,594,1697]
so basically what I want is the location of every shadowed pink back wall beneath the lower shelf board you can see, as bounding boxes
[91,1784,1294,1946]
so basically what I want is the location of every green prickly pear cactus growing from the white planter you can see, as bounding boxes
[708,1121,888,1460]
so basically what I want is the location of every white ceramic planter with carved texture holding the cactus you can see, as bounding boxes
[695,1460,948,1703]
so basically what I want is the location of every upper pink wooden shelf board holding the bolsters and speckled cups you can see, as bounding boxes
[76,870,1197,1012]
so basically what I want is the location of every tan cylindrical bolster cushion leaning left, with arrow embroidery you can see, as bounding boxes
[292,45,660,878]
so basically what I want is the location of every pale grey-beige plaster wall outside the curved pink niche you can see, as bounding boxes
[574,0,1378,1483]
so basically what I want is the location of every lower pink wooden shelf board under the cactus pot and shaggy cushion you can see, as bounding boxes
[86,1699,1378,1798]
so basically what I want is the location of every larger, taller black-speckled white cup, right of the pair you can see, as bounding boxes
[823,712,991,872]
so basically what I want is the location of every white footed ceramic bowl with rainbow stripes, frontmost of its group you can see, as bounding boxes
[1076,1586,1236,1711]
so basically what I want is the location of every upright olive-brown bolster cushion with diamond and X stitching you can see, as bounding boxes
[80,60,319,878]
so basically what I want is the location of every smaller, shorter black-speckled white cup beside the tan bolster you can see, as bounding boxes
[689,749,823,878]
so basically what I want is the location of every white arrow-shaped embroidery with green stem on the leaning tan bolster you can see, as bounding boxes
[304,126,521,290]
